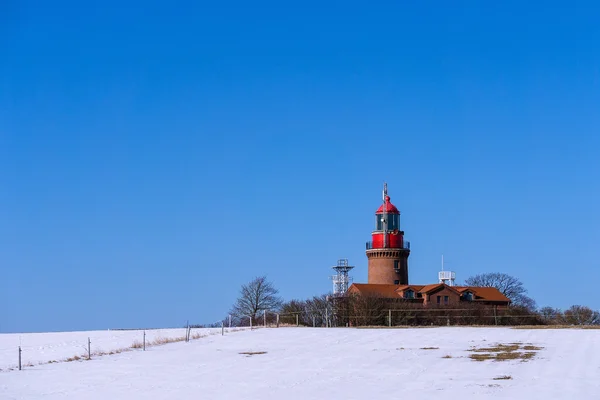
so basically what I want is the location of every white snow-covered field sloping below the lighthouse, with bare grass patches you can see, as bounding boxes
[0,327,600,400]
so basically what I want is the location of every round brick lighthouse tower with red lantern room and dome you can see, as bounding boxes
[367,183,410,285]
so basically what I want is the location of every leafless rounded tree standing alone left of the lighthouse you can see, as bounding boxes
[230,276,282,321]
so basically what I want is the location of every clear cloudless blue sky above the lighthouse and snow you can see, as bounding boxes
[0,0,600,332]
